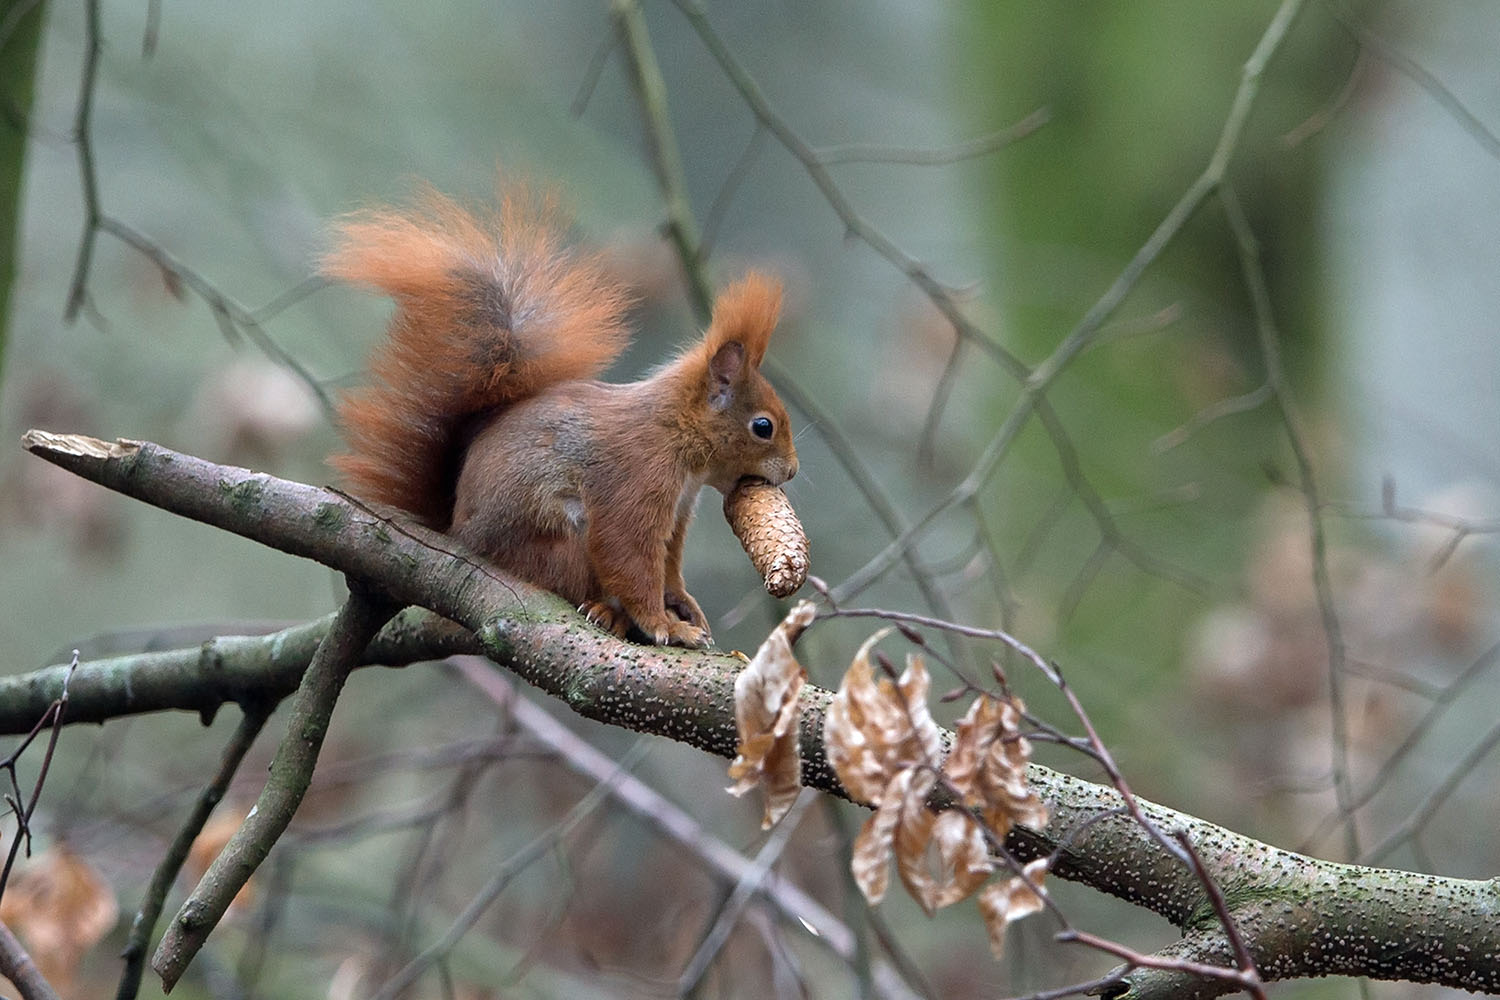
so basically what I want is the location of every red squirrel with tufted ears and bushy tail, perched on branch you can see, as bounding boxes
[323,189,797,648]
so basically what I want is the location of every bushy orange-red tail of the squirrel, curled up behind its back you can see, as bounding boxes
[323,190,630,528]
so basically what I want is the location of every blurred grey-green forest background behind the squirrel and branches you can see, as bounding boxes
[0,0,1500,1000]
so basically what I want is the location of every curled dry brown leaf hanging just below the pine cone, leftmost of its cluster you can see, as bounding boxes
[729,601,816,829]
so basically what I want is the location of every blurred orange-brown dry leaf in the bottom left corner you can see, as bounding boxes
[0,843,120,991]
